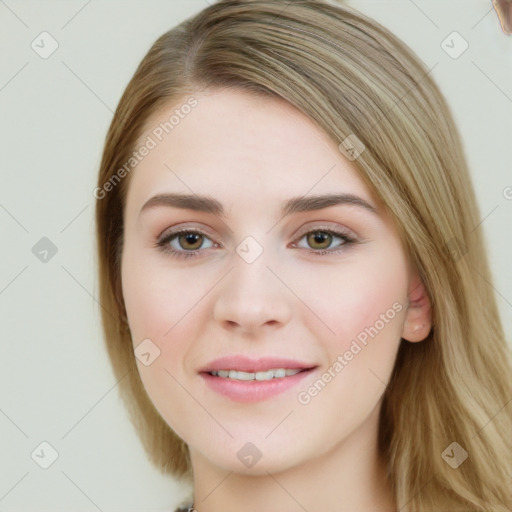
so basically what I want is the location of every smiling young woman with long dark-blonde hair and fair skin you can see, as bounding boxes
[96,0,512,512]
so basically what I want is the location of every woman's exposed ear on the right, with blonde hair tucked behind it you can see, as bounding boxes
[402,272,432,343]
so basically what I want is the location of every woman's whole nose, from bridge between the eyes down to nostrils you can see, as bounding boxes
[214,237,292,330]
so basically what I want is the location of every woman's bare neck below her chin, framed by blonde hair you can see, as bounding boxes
[190,408,396,512]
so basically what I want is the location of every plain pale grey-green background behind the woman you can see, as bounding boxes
[0,0,512,512]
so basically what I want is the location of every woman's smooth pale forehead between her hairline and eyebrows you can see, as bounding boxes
[129,90,372,209]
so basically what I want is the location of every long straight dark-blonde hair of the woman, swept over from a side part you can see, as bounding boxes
[96,0,512,512]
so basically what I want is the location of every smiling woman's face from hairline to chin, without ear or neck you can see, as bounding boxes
[122,90,424,474]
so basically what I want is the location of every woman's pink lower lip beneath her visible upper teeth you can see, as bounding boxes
[200,368,314,403]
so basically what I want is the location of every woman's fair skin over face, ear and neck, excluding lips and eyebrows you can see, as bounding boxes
[121,90,431,512]
